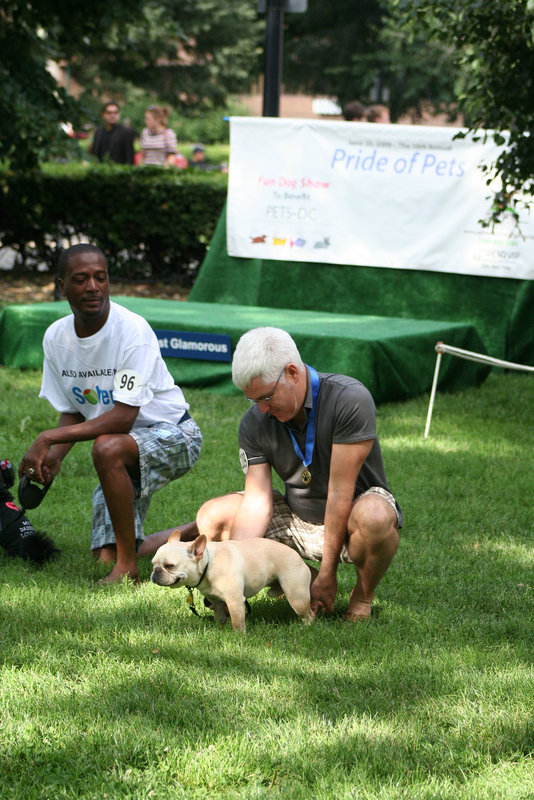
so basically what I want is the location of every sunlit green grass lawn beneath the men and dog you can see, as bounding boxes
[0,369,534,800]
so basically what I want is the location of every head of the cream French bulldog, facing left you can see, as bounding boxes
[150,530,207,586]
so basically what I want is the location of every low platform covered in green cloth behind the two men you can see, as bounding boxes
[0,296,489,402]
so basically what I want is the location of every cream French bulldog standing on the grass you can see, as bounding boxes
[151,530,314,631]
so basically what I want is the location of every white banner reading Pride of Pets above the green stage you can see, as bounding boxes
[227,117,534,279]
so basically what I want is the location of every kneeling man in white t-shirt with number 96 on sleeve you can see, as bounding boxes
[19,244,202,583]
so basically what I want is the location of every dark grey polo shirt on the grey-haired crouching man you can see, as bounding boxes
[239,372,398,524]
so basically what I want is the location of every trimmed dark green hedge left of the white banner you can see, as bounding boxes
[0,164,227,286]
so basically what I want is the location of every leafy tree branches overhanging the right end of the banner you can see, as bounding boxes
[395,0,534,223]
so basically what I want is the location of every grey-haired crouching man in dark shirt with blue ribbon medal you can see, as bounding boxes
[196,328,403,620]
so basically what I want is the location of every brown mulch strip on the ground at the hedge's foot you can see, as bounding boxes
[0,272,189,306]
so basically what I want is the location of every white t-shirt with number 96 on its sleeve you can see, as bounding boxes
[39,302,189,428]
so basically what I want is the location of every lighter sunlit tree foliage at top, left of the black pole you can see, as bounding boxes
[71,0,259,111]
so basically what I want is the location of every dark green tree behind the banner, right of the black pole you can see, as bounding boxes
[284,0,462,120]
